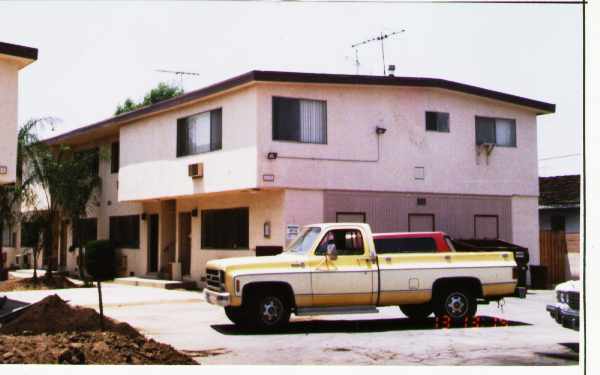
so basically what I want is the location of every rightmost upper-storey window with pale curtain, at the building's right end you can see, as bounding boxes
[475,116,517,147]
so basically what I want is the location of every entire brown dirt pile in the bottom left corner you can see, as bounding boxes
[0,295,197,364]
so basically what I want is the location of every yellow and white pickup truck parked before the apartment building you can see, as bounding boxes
[204,223,517,330]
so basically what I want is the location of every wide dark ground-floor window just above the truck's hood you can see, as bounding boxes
[201,207,250,249]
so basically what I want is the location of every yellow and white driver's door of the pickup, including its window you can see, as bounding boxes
[311,228,377,306]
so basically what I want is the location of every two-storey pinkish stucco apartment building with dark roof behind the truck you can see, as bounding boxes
[42,71,555,281]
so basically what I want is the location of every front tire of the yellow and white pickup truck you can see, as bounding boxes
[248,291,291,331]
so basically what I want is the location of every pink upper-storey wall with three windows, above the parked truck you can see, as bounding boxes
[257,83,538,195]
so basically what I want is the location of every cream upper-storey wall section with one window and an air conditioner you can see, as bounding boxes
[119,88,257,201]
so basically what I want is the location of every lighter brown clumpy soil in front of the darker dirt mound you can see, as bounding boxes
[0,332,198,365]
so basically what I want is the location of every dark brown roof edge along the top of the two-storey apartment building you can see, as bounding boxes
[45,70,556,144]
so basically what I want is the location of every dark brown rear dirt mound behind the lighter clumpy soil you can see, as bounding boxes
[0,294,140,337]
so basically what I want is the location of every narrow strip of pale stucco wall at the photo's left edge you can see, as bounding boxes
[0,56,18,185]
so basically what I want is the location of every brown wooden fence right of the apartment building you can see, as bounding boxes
[540,230,567,286]
